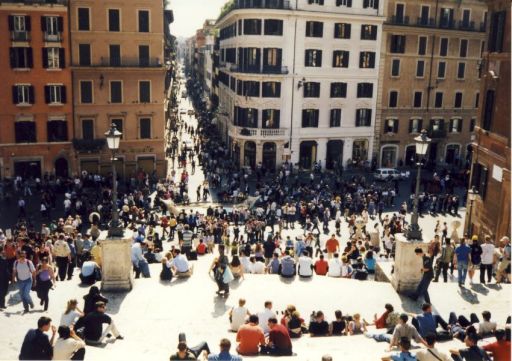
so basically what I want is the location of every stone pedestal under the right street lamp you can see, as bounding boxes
[391,233,428,295]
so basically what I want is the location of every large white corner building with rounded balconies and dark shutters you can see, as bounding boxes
[217,0,384,169]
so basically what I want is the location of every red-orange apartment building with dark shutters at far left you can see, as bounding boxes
[0,0,76,178]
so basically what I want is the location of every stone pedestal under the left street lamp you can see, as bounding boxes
[98,231,133,292]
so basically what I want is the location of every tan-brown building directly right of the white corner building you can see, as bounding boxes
[374,0,487,168]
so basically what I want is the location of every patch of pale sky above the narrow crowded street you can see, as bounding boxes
[170,0,227,38]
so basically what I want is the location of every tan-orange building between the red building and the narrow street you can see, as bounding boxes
[70,0,166,177]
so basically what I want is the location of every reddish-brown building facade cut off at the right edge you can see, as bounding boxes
[466,0,511,241]
